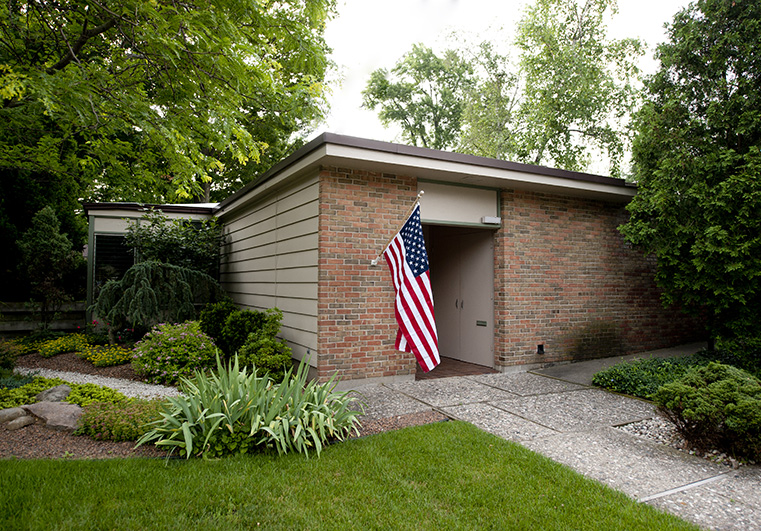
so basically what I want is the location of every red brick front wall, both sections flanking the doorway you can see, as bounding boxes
[317,167,699,380]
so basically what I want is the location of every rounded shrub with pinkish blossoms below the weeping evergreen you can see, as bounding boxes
[132,321,216,384]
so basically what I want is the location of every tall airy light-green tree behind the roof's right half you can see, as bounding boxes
[510,0,643,176]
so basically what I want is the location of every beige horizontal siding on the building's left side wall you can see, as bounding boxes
[220,176,319,366]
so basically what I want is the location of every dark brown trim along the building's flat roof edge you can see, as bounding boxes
[218,133,636,209]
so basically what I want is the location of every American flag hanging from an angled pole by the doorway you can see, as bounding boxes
[383,205,439,372]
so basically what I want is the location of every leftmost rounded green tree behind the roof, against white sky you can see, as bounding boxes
[362,44,471,149]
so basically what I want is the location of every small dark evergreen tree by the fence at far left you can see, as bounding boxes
[18,207,84,328]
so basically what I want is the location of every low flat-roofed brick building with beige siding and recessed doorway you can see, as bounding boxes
[84,133,701,380]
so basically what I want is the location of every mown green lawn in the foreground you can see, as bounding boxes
[0,422,698,530]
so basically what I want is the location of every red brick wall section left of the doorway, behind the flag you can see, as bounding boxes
[317,168,417,380]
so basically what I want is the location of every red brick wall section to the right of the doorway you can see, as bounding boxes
[495,191,700,367]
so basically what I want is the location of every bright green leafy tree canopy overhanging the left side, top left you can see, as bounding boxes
[0,0,334,201]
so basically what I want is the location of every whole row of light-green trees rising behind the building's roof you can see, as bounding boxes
[364,0,644,176]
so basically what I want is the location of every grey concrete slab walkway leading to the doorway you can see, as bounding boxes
[350,345,761,530]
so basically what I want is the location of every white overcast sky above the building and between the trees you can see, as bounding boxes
[318,0,689,142]
